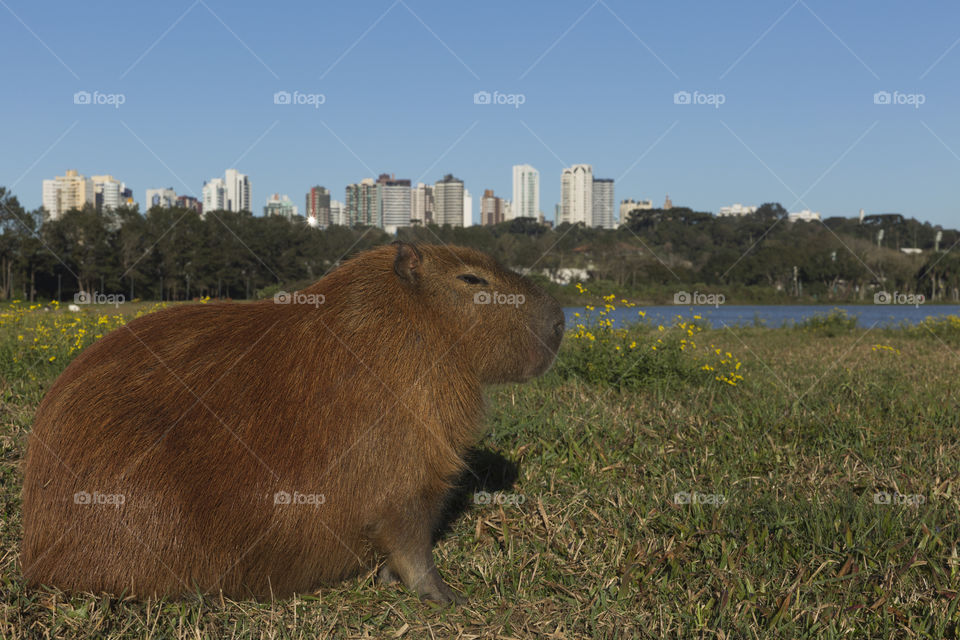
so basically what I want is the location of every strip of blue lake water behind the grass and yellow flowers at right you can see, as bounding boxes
[563,304,960,328]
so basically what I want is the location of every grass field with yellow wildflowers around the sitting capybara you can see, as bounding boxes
[0,301,960,638]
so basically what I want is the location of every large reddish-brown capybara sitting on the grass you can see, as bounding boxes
[21,243,564,602]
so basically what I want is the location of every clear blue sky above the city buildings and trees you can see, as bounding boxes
[0,0,960,227]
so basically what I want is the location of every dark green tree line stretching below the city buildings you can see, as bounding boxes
[0,187,960,301]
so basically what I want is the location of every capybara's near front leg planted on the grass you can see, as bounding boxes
[374,512,464,603]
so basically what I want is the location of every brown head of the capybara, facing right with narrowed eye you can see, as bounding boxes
[392,242,564,383]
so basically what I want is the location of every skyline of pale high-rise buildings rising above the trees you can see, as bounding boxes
[31,164,944,234]
